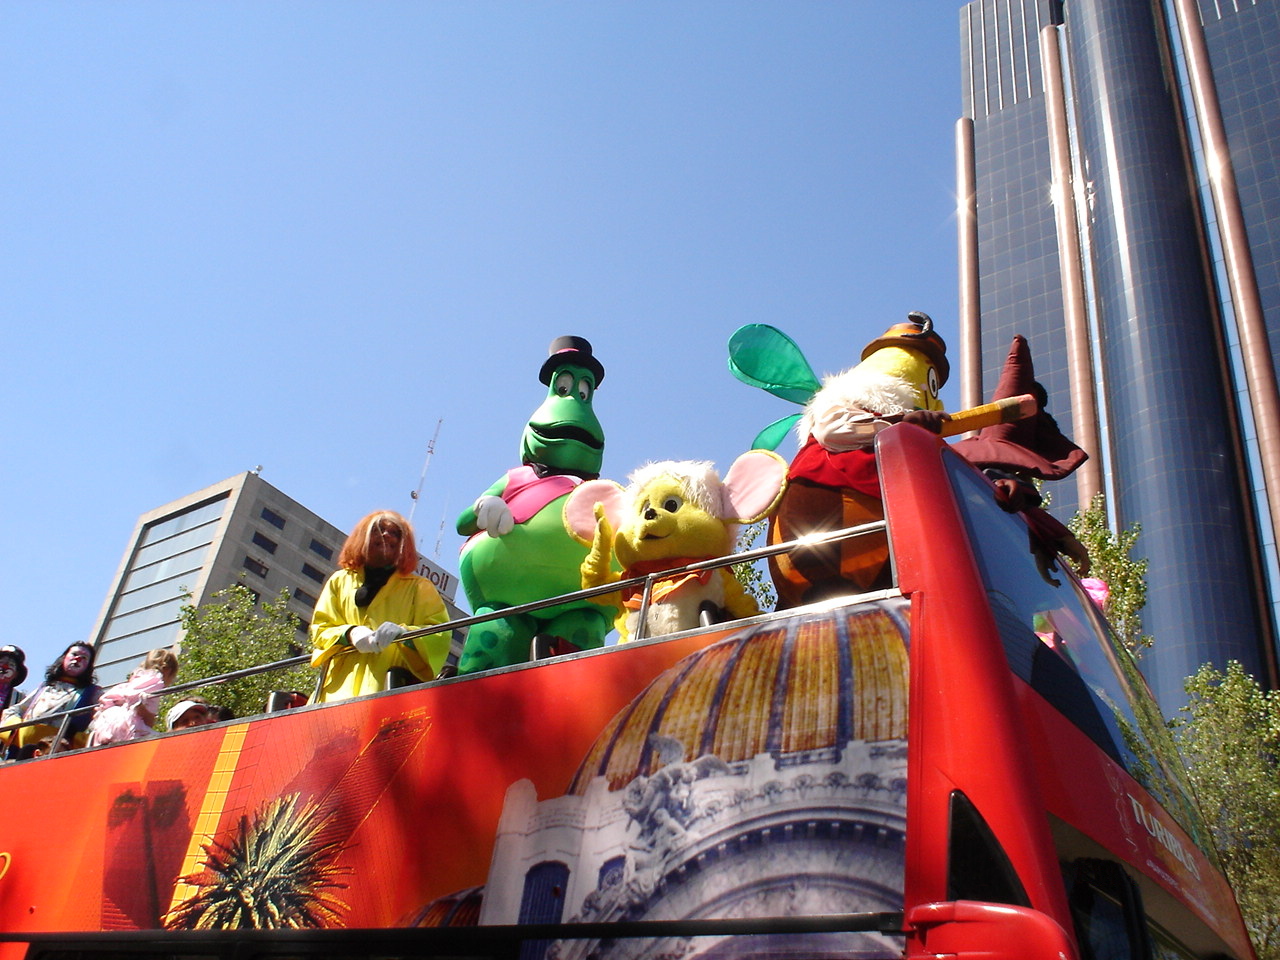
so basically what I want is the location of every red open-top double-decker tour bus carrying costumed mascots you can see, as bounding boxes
[0,425,1253,960]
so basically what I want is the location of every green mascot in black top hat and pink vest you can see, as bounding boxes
[457,337,618,673]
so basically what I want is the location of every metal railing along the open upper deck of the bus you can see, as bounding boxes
[0,520,886,754]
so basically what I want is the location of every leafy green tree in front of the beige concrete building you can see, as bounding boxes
[164,584,315,717]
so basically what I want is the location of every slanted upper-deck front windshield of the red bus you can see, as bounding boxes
[946,454,1210,851]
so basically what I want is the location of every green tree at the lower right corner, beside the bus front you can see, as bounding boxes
[1175,660,1280,960]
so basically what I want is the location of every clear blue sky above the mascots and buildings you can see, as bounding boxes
[0,0,960,666]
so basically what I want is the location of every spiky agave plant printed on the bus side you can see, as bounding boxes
[165,794,349,931]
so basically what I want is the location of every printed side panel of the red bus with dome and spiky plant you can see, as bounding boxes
[0,599,909,957]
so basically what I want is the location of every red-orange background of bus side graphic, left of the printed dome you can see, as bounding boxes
[0,636,714,932]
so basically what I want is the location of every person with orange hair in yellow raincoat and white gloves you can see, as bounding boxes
[311,509,449,703]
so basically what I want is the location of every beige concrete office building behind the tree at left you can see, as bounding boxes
[90,472,462,685]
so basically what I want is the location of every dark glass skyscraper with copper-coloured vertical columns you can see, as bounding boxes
[957,0,1280,713]
